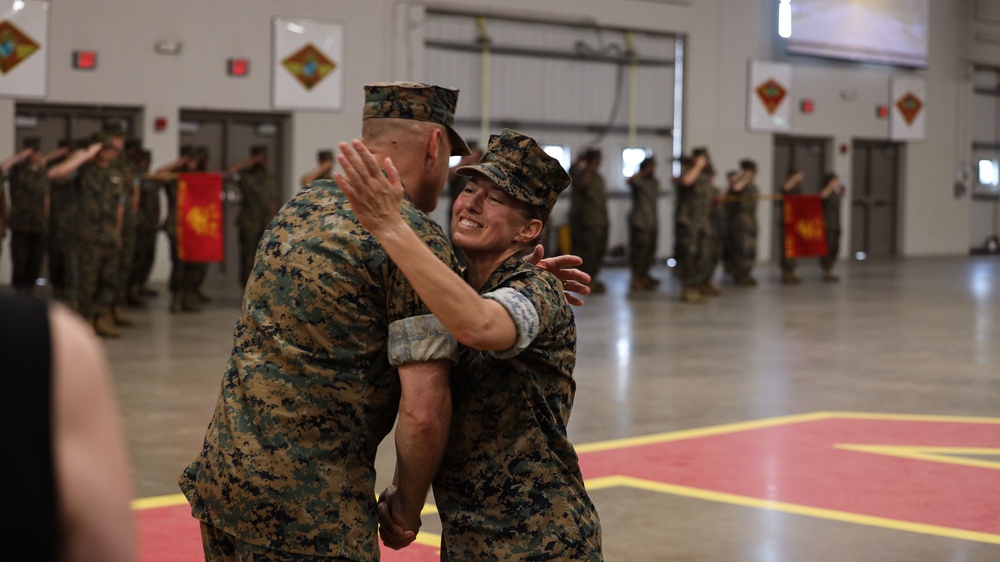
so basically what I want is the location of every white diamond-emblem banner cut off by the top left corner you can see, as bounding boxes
[0,0,49,98]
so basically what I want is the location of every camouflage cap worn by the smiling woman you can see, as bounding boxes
[456,129,571,210]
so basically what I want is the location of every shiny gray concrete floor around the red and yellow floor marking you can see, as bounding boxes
[92,256,1000,562]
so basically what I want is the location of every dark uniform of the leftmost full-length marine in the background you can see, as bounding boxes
[8,160,49,292]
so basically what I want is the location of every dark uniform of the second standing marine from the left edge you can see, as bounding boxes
[49,173,80,307]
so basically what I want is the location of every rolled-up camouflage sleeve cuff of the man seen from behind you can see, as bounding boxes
[388,314,458,367]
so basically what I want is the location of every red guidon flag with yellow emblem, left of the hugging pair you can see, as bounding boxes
[177,174,223,262]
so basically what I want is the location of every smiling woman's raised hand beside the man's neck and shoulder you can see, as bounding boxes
[333,139,405,234]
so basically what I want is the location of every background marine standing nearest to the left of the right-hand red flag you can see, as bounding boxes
[725,160,760,287]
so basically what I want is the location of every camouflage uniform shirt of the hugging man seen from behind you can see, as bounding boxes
[180,180,457,561]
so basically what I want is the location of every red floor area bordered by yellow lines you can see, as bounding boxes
[138,414,1000,562]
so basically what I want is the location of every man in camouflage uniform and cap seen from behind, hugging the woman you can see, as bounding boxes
[179,82,468,562]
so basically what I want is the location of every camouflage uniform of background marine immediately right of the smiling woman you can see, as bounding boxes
[569,169,608,279]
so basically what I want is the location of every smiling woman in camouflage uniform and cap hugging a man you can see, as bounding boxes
[337,129,603,562]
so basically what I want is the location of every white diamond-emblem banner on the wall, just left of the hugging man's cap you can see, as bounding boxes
[271,17,344,111]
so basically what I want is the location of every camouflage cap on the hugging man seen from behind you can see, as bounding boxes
[362,82,470,156]
